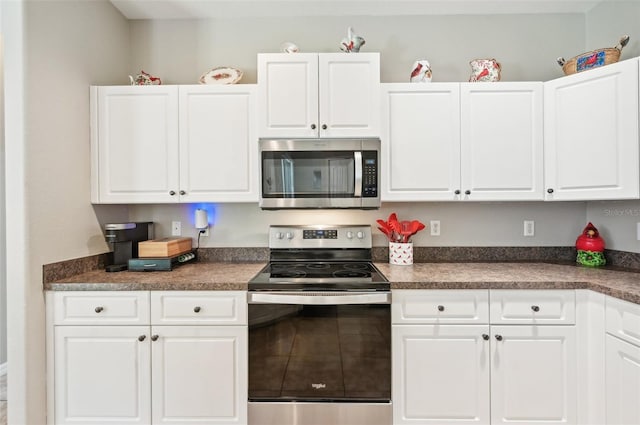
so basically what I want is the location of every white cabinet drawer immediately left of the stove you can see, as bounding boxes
[151,291,247,325]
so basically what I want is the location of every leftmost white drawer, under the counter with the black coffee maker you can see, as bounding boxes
[53,291,149,325]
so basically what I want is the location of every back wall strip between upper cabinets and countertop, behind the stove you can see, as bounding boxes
[129,202,586,247]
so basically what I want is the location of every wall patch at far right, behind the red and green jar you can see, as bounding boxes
[587,200,640,253]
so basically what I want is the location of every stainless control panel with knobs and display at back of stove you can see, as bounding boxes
[269,225,371,249]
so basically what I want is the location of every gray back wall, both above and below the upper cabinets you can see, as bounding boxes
[121,10,586,247]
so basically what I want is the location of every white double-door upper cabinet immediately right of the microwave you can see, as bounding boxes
[381,82,543,201]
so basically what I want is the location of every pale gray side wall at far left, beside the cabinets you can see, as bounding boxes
[7,0,129,425]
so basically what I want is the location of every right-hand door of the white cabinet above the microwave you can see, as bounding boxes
[318,53,380,137]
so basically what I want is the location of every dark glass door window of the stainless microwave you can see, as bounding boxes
[262,151,355,198]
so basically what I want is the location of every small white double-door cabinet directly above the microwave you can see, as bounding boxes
[258,53,380,138]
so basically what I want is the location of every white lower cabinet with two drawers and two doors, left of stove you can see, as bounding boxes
[47,291,248,425]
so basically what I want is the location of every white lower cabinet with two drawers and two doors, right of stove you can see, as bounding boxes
[392,290,577,425]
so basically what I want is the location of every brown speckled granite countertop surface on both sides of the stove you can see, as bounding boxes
[44,262,640,304]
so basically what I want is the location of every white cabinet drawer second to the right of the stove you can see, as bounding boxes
[490,289,576,325]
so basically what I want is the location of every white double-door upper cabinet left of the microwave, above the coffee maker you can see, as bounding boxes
[91,84,258,203]
